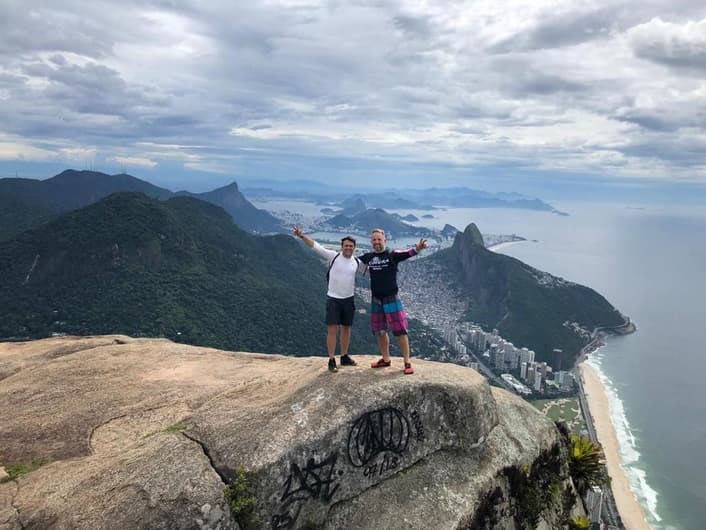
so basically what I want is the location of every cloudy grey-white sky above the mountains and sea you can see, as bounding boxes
[0,0,706,196]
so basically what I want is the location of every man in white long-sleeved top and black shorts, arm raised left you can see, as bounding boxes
[294,226,366,372]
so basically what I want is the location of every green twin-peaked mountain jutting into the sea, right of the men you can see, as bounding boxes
[429,224,625,368]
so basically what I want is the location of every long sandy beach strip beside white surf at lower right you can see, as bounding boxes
[579,363,650,530]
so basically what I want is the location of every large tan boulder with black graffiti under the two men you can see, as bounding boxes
[0,336,576,529]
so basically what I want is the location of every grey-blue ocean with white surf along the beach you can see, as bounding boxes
[258,197,706,530]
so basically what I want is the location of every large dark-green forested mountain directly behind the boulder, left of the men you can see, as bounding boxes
[0,193,358,355]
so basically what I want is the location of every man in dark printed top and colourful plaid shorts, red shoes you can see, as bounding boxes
[360,228,427,374]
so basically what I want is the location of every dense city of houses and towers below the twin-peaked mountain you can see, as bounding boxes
[356,245,625,529]
